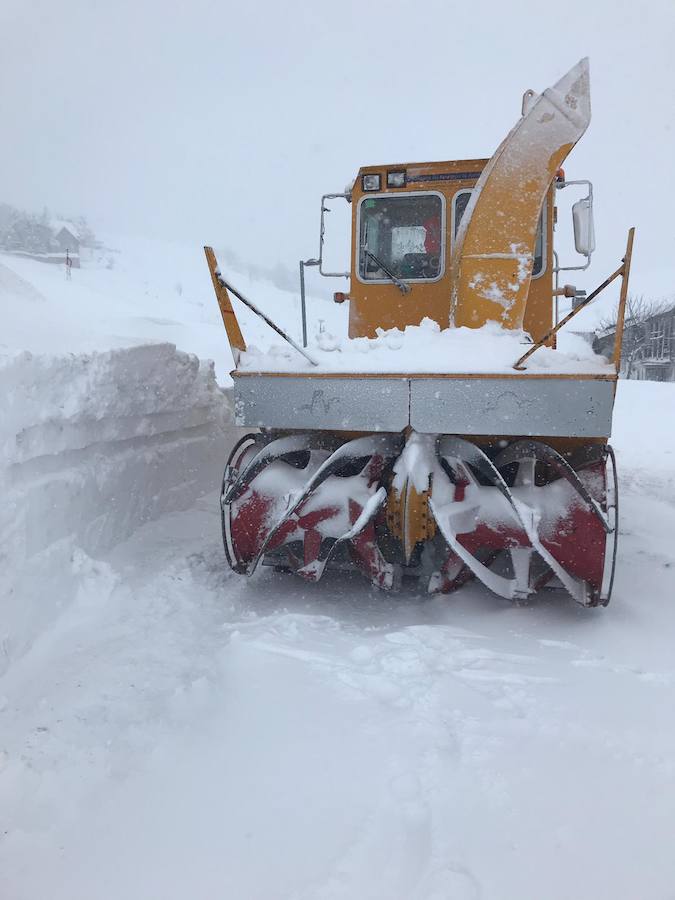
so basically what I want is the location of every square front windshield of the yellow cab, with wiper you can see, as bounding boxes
[359,194,443,281]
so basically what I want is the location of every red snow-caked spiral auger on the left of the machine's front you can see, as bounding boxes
[223,434,401,588]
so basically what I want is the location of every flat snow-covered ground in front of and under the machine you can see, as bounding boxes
[0,460,675,900]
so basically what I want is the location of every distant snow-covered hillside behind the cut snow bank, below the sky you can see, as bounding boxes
[0,238,346,385]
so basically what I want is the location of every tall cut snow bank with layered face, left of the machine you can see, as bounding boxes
[0,344,231,671]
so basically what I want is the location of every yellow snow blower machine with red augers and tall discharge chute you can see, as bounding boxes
[205,59,634,607]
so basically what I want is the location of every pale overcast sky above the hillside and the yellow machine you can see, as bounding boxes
[0,0,675,302]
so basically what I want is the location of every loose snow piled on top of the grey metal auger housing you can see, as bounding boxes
[239,318,614,374]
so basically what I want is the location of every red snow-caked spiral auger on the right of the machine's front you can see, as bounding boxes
[430,436,616,606]
